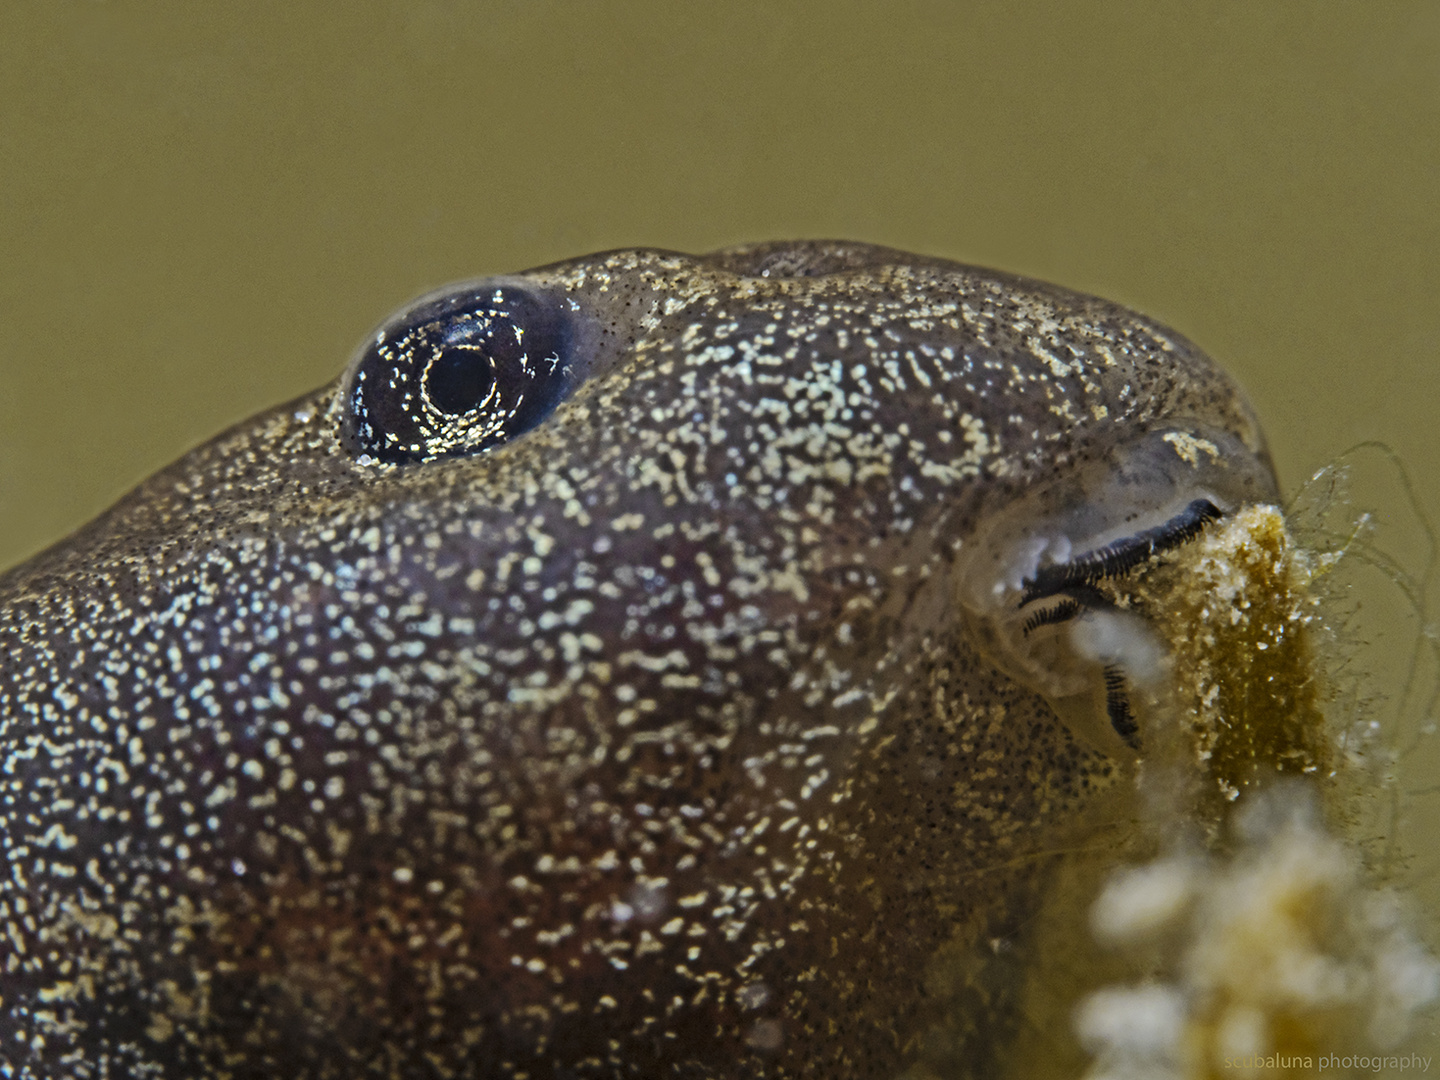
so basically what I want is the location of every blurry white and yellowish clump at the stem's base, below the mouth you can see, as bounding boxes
[1076,782,1440,1080]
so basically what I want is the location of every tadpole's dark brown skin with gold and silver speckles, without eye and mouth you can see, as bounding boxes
[0,243,1264,1080]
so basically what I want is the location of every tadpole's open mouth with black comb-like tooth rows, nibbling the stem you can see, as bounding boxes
[959,425,1276,755]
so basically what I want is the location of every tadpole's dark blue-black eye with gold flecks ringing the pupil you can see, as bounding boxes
[344,284,570,462]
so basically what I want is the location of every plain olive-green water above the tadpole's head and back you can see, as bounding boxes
[0,0,1440,1065]
